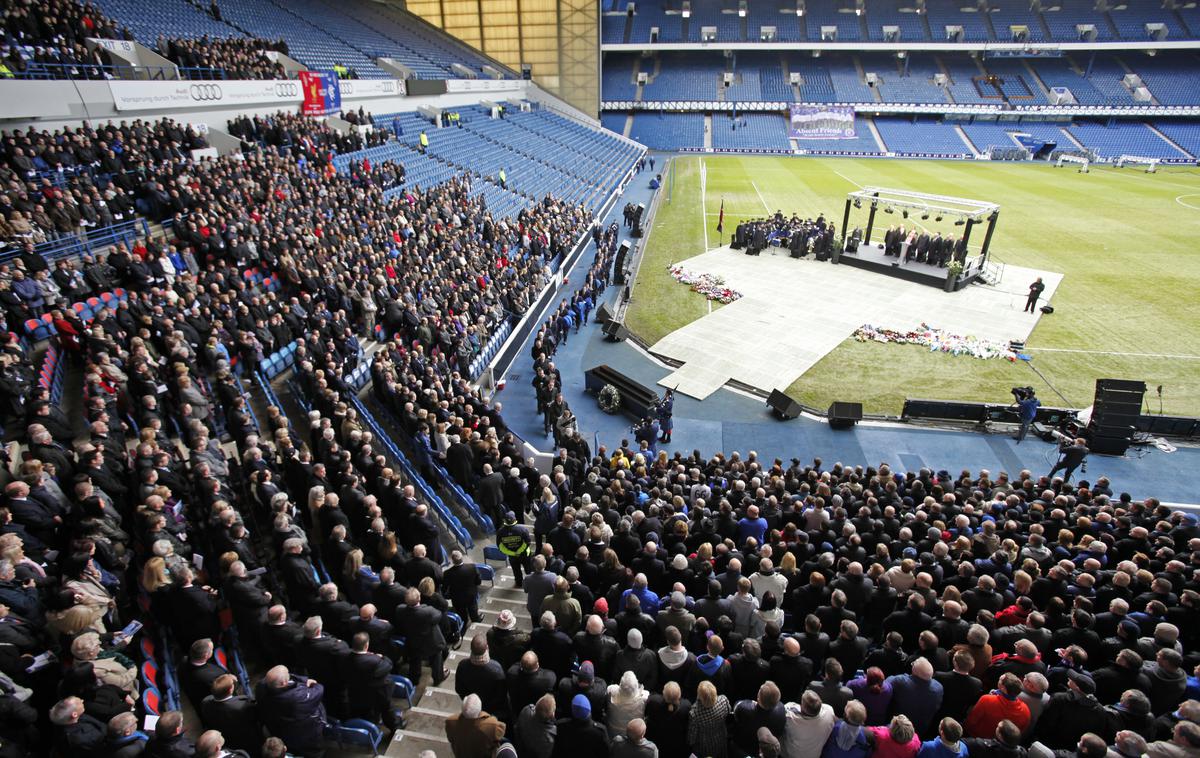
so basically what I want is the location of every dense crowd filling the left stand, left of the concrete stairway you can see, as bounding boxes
[0,101,600,756]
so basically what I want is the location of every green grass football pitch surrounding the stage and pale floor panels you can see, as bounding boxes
[626,156,1200,415]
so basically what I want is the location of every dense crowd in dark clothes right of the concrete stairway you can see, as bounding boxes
[429,443,1200,758]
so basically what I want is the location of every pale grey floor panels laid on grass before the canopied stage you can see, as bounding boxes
[652,247,1062,399]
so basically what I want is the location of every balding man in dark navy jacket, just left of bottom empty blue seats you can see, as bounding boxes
[256,666,326,756]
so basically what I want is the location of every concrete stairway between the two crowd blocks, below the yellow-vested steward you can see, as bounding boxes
[384,566,533,758]
